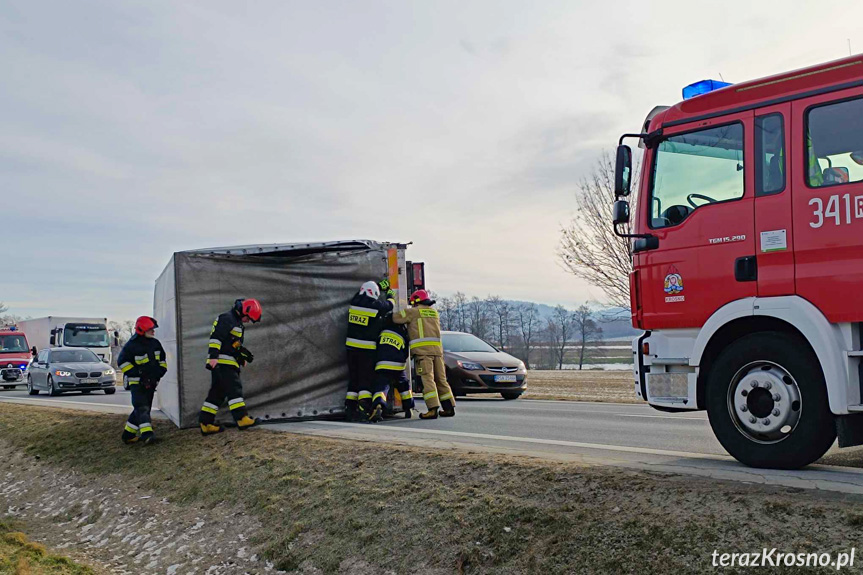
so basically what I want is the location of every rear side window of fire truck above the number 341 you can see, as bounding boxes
[806,99,863,188]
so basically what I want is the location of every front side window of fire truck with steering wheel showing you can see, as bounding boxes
[649,123,743,229]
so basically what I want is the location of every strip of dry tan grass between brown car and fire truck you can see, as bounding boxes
[524,370,643,403]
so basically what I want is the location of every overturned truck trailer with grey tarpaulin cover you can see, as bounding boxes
[154,240,408,427]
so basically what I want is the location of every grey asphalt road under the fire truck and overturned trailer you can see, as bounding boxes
[5,389,863,494]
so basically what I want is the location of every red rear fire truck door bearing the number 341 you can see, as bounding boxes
[791,87,863,323]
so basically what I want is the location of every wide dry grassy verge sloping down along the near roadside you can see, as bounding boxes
[0,404,863,574]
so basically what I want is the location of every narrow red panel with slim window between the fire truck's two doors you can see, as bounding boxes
[753,104,795,297]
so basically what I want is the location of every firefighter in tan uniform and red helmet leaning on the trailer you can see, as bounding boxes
[393,290,455,419]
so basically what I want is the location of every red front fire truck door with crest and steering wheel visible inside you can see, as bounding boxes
[639,112,757,329]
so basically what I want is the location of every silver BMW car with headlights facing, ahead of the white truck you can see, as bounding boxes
[27,347,117,395]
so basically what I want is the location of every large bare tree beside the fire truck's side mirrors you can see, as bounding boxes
[557,152,638,308]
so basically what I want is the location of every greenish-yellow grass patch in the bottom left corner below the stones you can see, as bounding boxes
[0,519,93,575]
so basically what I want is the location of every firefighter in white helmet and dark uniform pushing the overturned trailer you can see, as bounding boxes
[345,280,395,421]
